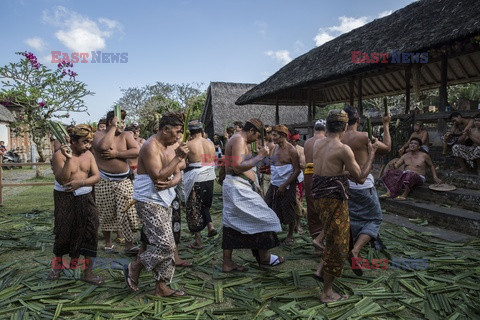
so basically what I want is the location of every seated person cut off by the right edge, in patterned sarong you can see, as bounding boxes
[452,113,480,175]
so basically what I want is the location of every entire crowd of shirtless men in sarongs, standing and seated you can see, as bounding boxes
[49,106,480,302]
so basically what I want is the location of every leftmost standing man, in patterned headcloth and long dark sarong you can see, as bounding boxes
[48,124,103,285]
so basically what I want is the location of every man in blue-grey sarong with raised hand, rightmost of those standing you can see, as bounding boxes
[342,106,392,275]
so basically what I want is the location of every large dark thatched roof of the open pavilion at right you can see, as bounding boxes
[236,0,480,105]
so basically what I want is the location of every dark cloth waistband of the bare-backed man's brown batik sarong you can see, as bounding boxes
[312,174,348,199]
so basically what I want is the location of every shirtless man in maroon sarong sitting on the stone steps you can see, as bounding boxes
[381,138,442,200]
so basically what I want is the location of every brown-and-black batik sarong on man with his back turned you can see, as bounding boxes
[312,175,350,277]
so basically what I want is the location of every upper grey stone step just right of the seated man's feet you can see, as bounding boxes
[410,185,480,212]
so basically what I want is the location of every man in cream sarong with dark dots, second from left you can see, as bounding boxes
[92,110,140,254]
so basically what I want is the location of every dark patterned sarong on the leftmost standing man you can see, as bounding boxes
[53,190,99,258]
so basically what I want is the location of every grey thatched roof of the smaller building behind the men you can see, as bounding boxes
[201,82,308,135]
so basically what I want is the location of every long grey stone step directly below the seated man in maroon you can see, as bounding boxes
[381,198,480,237]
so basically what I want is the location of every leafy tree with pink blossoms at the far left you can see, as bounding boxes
[0,51,93,162]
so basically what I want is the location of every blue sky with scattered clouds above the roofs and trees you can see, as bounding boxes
[0,0,413,122]
